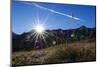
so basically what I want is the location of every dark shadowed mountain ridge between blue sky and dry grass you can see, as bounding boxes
[12,26,96,51]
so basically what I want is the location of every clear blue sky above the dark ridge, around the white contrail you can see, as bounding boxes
[12,1,96,34]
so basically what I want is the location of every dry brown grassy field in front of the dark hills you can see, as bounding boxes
[12,41,96,65]
